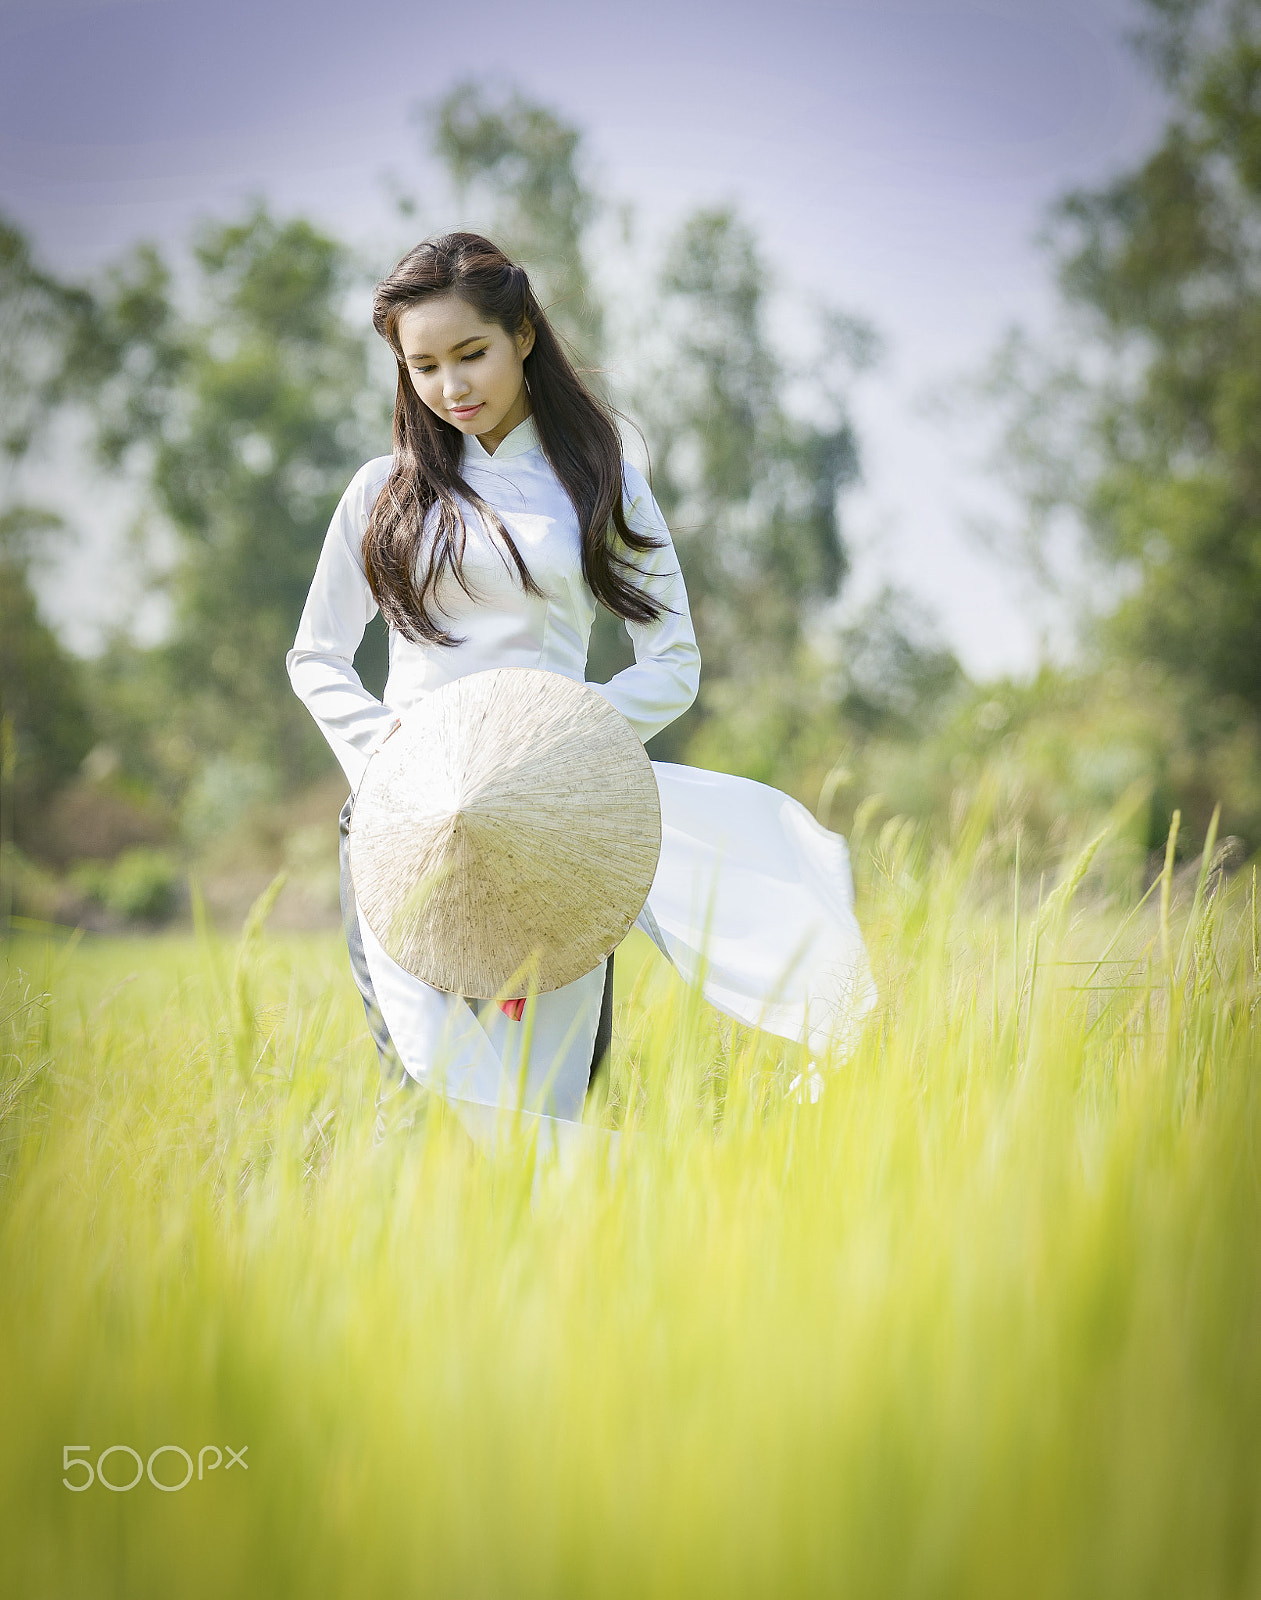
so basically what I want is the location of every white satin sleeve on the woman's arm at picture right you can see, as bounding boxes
[590,462,701,742]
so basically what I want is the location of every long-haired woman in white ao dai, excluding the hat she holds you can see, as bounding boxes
[286,234,872,1145]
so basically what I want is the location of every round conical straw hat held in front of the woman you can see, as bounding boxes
[350,667,661,1000]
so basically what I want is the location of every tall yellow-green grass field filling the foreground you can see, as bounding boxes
[0,814,1261,1600]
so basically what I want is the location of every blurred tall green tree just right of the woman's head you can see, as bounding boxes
[637,208,877,760]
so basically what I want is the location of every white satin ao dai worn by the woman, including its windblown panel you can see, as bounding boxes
[286,235,874,1122]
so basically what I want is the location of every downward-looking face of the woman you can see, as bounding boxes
[397,293,534,451]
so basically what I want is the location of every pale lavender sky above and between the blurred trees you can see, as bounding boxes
[0,0,1167,677]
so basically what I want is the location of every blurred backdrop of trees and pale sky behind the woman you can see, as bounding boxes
[0,0,1261,931]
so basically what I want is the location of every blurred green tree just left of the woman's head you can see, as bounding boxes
[86,205,389,812]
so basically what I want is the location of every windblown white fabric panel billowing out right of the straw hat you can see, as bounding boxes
[645,762,875,1054]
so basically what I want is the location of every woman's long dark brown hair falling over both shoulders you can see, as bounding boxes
[363,234,661,645]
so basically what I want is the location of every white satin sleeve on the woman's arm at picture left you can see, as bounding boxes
[285,458,395,789]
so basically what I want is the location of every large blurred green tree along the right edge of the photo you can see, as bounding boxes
[1058,3,1261,717]
